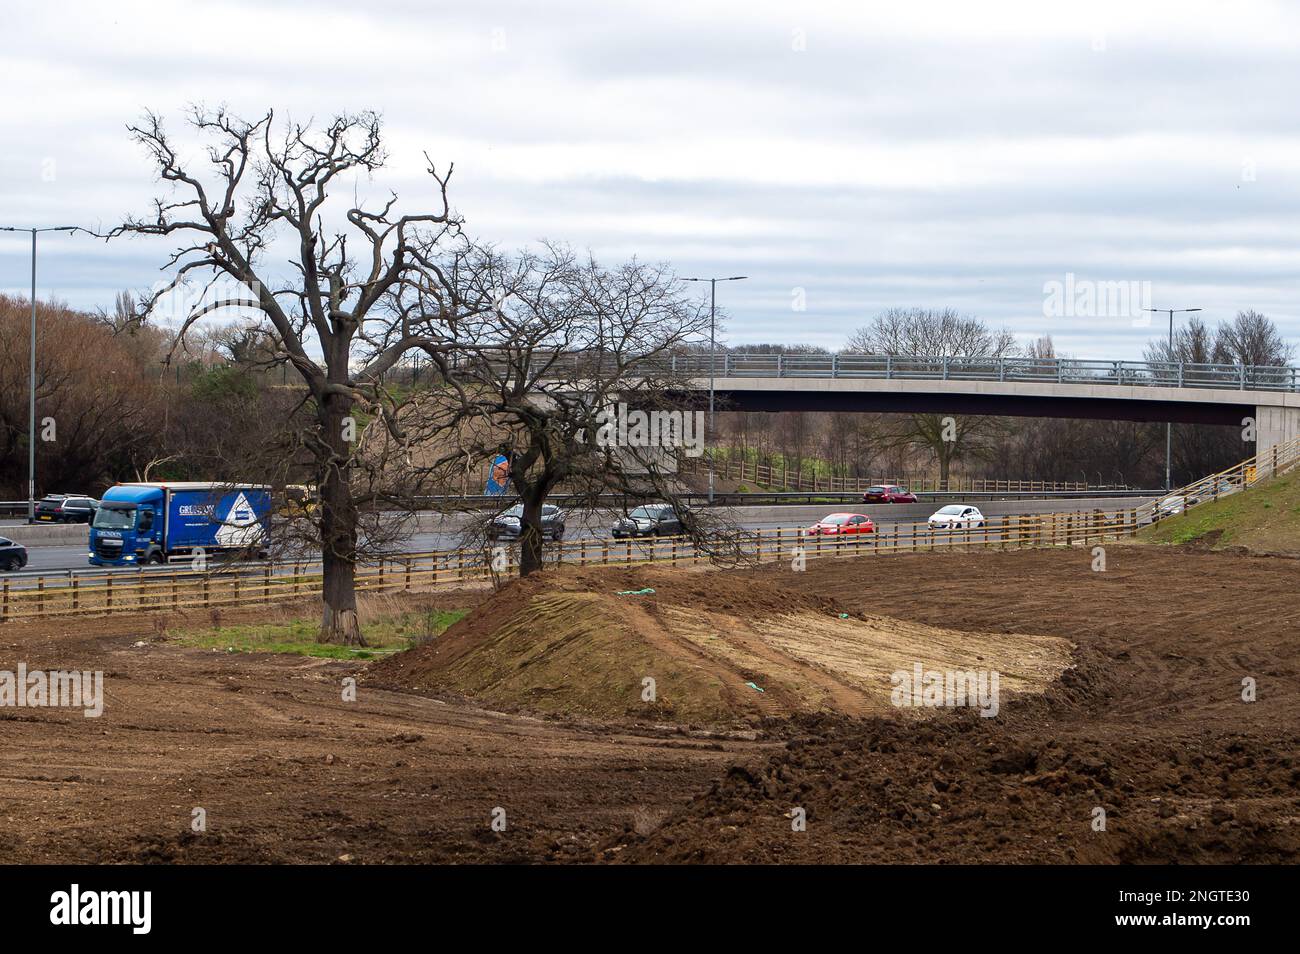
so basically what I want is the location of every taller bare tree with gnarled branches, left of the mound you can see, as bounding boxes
[111,108,478,645]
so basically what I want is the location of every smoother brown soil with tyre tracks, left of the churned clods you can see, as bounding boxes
[0,594,771,863]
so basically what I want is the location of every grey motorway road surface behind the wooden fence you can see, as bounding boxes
[0,496,1154,577]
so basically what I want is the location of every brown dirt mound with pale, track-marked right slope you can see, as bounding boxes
[367,568,1071,724]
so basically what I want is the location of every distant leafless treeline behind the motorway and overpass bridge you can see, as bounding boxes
[0,295,1292,499]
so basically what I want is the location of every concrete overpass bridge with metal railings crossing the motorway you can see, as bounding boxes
[657,354,1300,452]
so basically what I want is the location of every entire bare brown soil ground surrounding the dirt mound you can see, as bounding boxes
[0,546,1300,863]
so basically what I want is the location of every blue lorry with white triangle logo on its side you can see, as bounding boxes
[88,481,270,567]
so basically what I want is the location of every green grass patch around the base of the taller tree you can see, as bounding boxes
[172,610,469,659]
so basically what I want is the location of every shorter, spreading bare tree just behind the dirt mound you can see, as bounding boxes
[428,244,709,576]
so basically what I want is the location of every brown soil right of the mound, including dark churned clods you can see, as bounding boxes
[610,546,1300,863]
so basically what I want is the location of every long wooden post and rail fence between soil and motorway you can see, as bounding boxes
[0,438,1300,623]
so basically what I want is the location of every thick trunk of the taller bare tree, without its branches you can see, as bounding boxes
[316,395,367,646]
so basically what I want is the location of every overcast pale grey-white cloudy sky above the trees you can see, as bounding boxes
[0,0,1300,357]
